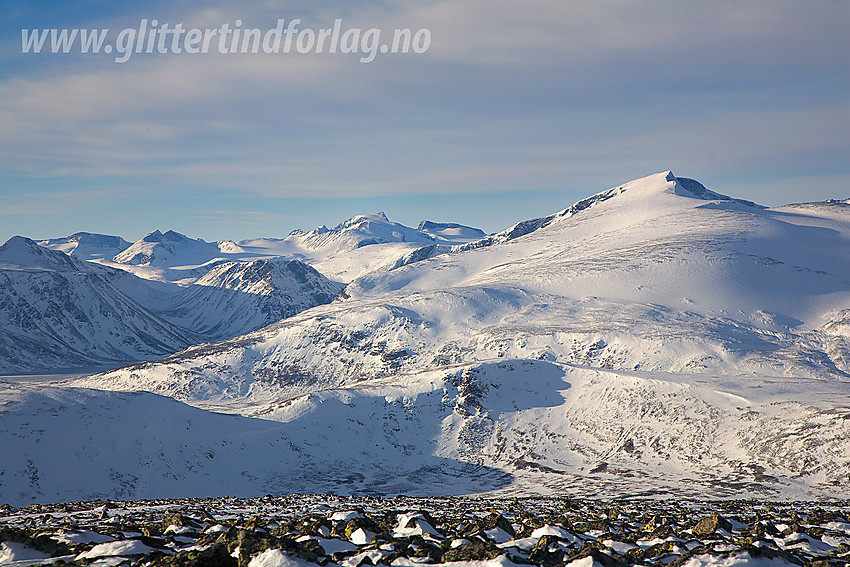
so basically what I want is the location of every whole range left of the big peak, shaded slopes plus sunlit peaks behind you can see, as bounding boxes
[0,213,484,374]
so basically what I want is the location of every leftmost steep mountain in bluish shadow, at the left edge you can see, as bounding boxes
[0,237,200,374]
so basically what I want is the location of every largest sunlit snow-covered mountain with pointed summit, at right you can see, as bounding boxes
[78,173,850,401]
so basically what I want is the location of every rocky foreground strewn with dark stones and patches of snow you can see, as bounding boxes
[0,495,850,567]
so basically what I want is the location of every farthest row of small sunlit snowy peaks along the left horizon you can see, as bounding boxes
[39,213,485,285]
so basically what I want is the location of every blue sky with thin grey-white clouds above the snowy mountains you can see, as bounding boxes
[0,0,850,241]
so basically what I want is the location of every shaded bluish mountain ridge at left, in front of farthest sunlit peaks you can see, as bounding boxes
[0,237,341,374]
